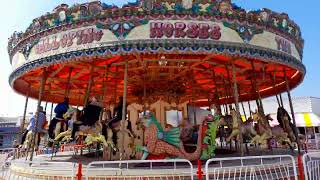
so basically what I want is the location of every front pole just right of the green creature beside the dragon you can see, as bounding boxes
[228,62,244,156]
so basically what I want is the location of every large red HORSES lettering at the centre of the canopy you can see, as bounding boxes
[150,22,221,40]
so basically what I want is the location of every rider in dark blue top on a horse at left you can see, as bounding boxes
[48,97,69,139]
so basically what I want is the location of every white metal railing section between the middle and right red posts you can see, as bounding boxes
[205,155,298,180]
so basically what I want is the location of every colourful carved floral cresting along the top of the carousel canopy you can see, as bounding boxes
[8,0,304,59]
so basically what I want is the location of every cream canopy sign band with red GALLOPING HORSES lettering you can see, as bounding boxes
[17,20,301,68]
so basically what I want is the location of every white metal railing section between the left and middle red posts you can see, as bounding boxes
[85,159,193,180]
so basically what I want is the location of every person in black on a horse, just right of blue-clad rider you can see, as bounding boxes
[71,97,102,140]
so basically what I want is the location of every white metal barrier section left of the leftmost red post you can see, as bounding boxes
[0,160,76,180]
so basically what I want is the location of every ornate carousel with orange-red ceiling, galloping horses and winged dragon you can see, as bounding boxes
[8,0,306,179]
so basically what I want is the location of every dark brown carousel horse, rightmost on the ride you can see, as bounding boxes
[277,107,298,142]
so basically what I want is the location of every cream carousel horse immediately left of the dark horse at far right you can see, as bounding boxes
[251,110,272,146]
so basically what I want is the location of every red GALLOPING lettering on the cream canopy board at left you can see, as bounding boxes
[35,28,103,54]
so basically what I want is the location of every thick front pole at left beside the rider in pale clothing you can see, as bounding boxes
[30,69,47,161]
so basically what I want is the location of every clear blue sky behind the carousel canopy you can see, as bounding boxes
[0,0,320,116]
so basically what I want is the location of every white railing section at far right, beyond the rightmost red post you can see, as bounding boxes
[302,152,320,180]
